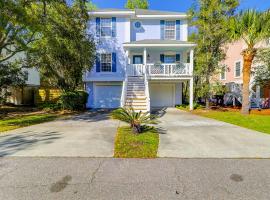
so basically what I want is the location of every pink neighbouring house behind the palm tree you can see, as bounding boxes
[218,41,270,107]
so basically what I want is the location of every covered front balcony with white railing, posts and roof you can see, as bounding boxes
[124,40,195,79]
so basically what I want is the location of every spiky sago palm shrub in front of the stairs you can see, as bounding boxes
[112,108,157,133]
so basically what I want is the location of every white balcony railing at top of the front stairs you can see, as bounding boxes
[127,63,192,77]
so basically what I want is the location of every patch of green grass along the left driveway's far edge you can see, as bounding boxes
[0,114,58,132]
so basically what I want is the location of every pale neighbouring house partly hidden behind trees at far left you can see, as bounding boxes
[7,52,40,105]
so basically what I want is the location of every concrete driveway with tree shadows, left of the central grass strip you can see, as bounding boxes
[0,112,119,157]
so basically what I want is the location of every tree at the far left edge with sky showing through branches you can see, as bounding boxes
[0,0,35,103]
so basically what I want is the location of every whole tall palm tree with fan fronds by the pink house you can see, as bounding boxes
[229,10,270,114]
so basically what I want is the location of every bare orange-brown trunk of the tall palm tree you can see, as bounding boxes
[241,49,255,115]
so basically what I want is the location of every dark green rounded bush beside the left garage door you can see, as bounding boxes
[58,91,88,110]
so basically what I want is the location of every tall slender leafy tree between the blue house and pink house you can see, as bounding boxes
[190,0,238,108]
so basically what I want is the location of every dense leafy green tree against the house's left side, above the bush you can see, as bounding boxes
[27,0,95,91]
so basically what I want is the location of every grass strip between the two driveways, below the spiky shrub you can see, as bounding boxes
[114,126,159,158]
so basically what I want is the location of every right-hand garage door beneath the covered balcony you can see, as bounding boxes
[150,84,174,107]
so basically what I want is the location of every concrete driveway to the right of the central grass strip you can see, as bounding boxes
[158,108,270,158]
